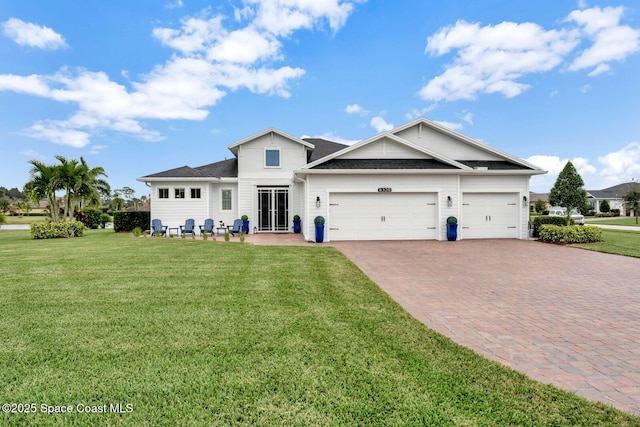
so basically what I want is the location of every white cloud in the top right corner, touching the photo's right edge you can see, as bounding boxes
[567,7,640,76]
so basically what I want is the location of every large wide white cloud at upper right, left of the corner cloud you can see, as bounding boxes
[420,21,578,101]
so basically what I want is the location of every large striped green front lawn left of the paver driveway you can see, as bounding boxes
[0,230,640,426]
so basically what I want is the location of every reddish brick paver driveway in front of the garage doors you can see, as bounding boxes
[332,240,640,414]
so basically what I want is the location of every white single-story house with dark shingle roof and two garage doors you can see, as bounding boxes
[138,118,546,241]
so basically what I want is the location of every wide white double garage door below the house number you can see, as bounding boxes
[327,193,437,240]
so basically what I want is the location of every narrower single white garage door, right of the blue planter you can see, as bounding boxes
[458,193,519,239]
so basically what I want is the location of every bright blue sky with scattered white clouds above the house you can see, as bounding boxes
[0,0,640,197]
